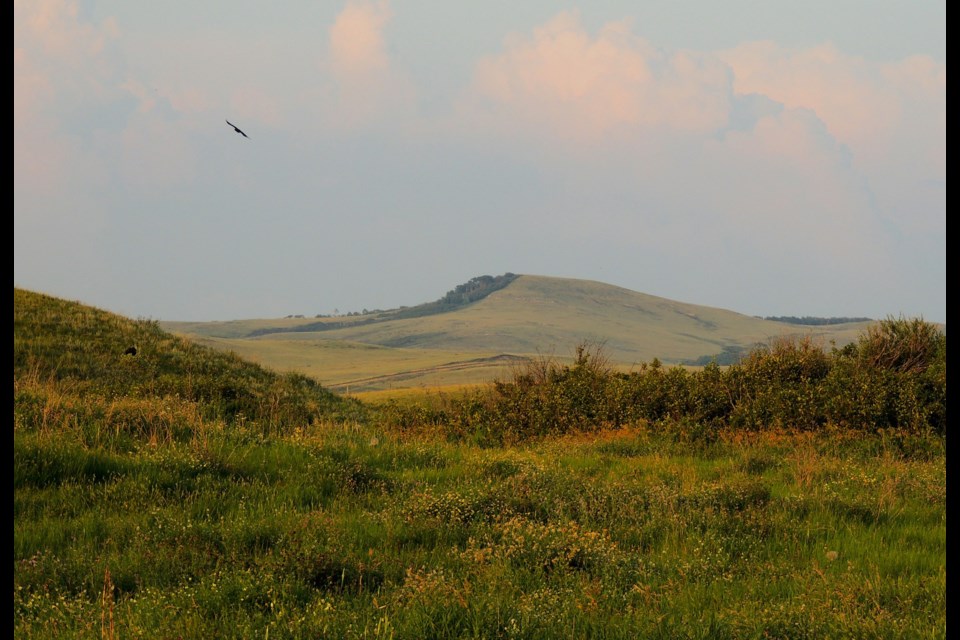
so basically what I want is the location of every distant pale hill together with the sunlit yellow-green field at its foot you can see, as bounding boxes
[161,275,869,390]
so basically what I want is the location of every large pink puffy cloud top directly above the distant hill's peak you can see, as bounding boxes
[463,12,732,143]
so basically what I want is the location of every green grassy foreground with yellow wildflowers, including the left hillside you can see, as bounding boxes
[13,291,946,638]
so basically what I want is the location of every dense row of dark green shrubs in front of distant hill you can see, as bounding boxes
[384,318,947,444]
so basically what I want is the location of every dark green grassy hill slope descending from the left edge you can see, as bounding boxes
[13,288,368,428]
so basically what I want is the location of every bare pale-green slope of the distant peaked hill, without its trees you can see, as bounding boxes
[272,276,840,363]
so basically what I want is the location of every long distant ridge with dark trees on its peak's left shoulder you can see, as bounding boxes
[161,273,869,366]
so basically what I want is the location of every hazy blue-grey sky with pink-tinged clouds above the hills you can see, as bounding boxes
[13,0,946,323]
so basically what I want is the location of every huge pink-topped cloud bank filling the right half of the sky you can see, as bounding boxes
[448,13,943,318]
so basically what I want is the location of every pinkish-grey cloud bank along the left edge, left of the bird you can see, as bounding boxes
[14,0,204,295]
